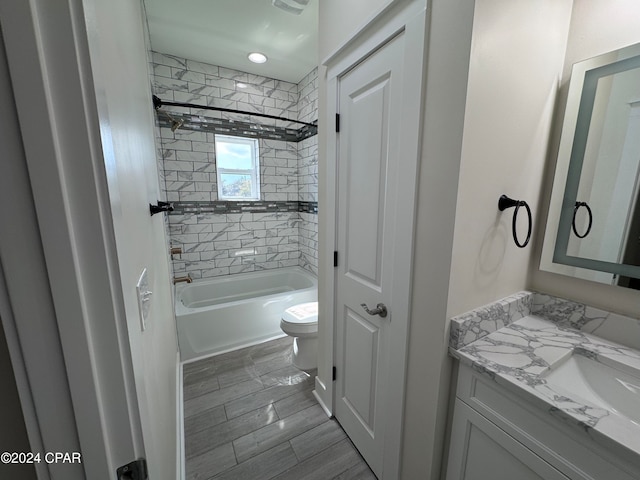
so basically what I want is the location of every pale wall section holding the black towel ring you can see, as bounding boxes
[448,0,571,317]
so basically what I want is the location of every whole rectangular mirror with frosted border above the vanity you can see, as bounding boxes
[540,44,640,289]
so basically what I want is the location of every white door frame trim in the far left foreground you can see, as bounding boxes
[0,0,144,479]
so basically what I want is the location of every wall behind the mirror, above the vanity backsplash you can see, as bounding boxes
[529,0,640,317]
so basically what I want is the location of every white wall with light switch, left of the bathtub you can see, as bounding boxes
[84,0,179,479]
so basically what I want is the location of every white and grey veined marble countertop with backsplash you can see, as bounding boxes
[449,292,640,463]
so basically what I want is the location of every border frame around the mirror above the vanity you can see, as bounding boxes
[540,43,640,283]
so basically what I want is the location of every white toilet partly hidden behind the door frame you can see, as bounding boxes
[280,302,318,370]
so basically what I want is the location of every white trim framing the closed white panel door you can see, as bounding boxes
[316,0,427,479]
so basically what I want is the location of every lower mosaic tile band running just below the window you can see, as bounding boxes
[169,200,318,215]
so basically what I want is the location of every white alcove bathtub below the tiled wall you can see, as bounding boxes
[175,267,318,362]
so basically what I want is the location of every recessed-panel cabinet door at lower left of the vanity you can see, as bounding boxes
[447,399,568,480]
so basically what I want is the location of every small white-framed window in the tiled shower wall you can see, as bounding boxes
[215,135,260,200]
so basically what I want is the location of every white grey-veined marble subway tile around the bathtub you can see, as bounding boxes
[153,52,318,278]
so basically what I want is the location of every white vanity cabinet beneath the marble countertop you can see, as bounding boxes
[446,365,640,480]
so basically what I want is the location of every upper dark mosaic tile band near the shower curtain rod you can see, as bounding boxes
[157,112,318,143]
